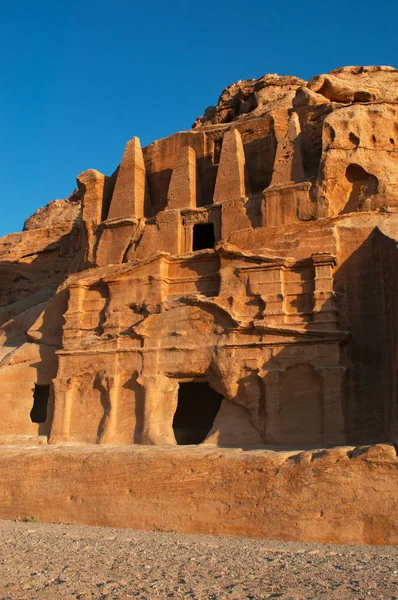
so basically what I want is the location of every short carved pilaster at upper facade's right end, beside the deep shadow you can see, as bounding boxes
[311,252,337,329]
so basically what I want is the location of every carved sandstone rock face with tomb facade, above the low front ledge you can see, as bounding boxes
[0,67,398,540]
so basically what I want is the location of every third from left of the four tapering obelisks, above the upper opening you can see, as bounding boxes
[213,127,248,203]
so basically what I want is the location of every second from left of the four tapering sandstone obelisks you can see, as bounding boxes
[167,146,202,208]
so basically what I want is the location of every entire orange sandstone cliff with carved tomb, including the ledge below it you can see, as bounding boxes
[0,67,398,544]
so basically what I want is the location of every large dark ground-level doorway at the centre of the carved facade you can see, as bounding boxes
[173,382,223,445]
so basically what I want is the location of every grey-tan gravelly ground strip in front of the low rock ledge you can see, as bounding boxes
[0,521,398,600]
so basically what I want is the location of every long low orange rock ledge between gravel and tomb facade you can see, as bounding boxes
[0,445,398,544]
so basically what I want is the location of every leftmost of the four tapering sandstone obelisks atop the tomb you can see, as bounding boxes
[108,137,150,220]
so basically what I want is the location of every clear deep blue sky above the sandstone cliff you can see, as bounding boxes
[0,0,398,235]
